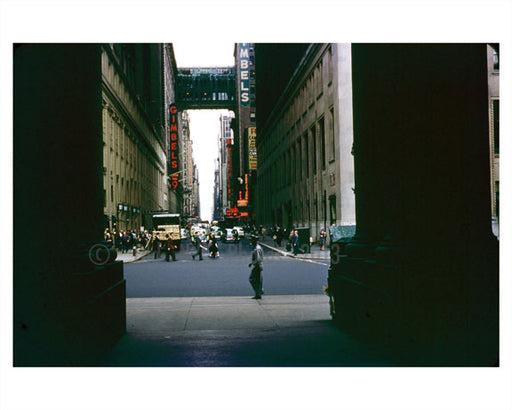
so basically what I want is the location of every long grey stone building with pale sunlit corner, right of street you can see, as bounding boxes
[256,44,355,239]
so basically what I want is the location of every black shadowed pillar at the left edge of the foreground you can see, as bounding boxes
[14,44,125,366]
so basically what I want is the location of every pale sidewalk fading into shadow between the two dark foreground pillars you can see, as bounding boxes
[98,295,393,367]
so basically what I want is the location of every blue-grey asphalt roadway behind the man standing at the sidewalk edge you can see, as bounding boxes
[124,239,328,298]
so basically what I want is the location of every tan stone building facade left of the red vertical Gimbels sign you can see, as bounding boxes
[101,44,178,230]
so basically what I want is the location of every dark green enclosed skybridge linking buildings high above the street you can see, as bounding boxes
[176,67,236,111]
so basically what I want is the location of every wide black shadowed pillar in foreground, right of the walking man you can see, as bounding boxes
[332,44,498,365]
